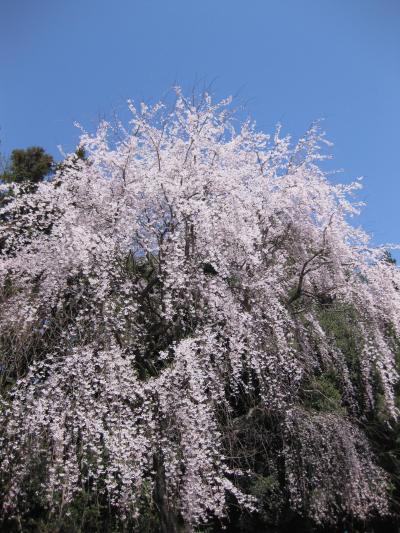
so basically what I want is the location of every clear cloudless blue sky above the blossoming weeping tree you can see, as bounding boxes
[0,0,400,258]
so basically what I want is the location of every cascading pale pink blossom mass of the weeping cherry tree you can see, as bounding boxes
[0,90,400,531]
